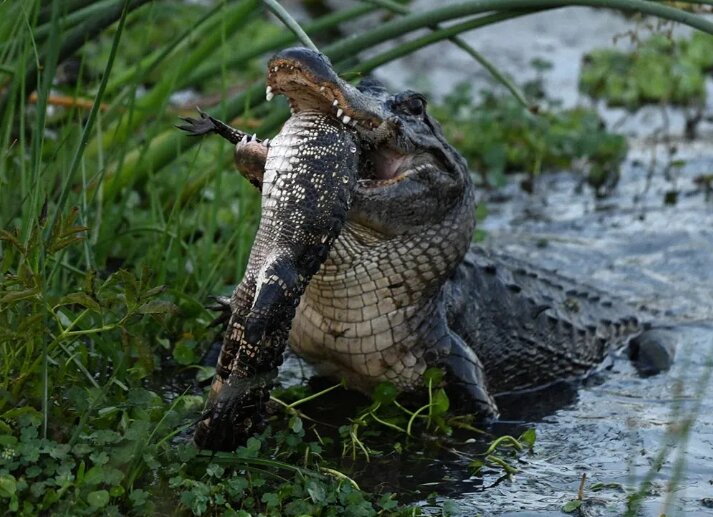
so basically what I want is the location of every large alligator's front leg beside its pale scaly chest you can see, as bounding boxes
[440,331,499,420]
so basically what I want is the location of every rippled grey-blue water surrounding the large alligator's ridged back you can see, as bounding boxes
[470,144,713,516]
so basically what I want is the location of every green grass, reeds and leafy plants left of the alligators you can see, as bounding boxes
[0,0,713,515]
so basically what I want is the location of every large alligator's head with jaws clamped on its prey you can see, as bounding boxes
[264,48,472,236]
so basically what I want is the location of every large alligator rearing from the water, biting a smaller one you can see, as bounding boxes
[178,48,660,449]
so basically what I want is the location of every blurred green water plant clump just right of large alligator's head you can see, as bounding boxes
[434,78,628,194]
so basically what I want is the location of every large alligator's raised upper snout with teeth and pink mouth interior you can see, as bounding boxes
[265,49,416,190]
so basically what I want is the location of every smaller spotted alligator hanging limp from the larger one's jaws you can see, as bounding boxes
[180,50,370,450]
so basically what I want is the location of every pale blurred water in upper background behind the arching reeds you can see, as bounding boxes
[372,4,713,140]
